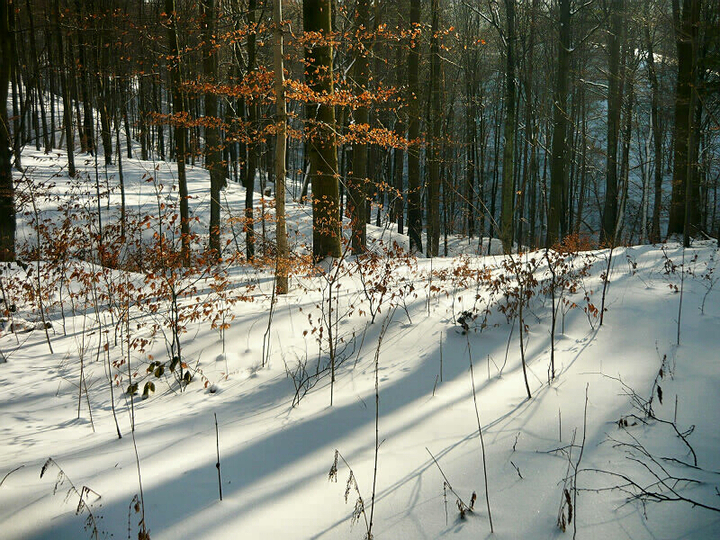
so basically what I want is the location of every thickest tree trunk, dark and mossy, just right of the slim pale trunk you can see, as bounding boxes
[303,0,341,261]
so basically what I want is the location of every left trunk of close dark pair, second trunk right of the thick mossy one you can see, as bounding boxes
[407,0,422,253]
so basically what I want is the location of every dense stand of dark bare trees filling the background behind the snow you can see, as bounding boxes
[0,0,720,259]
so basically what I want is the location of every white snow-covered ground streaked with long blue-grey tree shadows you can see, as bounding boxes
[0,151,720,539]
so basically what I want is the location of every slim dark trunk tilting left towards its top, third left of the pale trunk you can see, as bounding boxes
[165,0,190,265]
